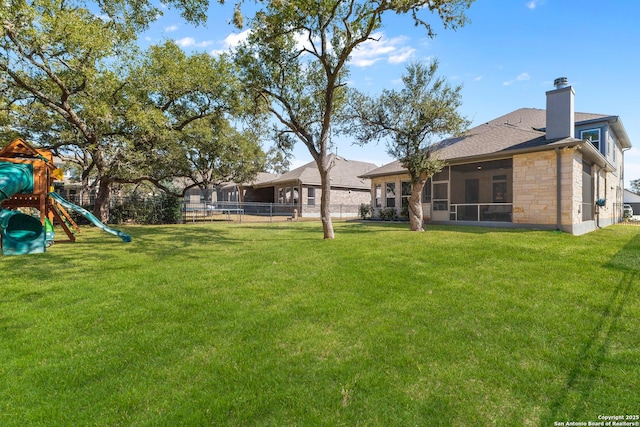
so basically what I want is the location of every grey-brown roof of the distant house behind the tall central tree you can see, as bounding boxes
[254,154,377,190]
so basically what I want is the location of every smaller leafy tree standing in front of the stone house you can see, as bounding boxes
[351,60,469,231]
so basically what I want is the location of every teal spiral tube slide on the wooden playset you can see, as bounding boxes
[0,162,46,255]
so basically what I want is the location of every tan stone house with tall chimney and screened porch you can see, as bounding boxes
[362,78,631,235]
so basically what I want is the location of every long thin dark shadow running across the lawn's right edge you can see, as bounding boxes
[542,232,640,425]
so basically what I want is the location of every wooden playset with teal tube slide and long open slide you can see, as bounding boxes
[0,139,131,255]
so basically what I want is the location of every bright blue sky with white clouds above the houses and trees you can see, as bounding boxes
[144,0,640,187]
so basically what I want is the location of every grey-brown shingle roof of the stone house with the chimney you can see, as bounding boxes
[363,108,631,178]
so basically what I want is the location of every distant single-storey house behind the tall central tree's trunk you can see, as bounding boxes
[244,154,377,217]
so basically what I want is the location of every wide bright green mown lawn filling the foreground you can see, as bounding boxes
[0,222,640,426]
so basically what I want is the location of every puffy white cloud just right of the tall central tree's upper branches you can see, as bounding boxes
[351,33,416,67]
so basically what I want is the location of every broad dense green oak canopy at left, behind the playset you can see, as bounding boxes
[0,0,264,220]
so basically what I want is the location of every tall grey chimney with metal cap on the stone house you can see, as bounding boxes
[546,77,576,139]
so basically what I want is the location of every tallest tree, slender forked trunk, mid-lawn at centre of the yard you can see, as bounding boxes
[236,0,473,239]
